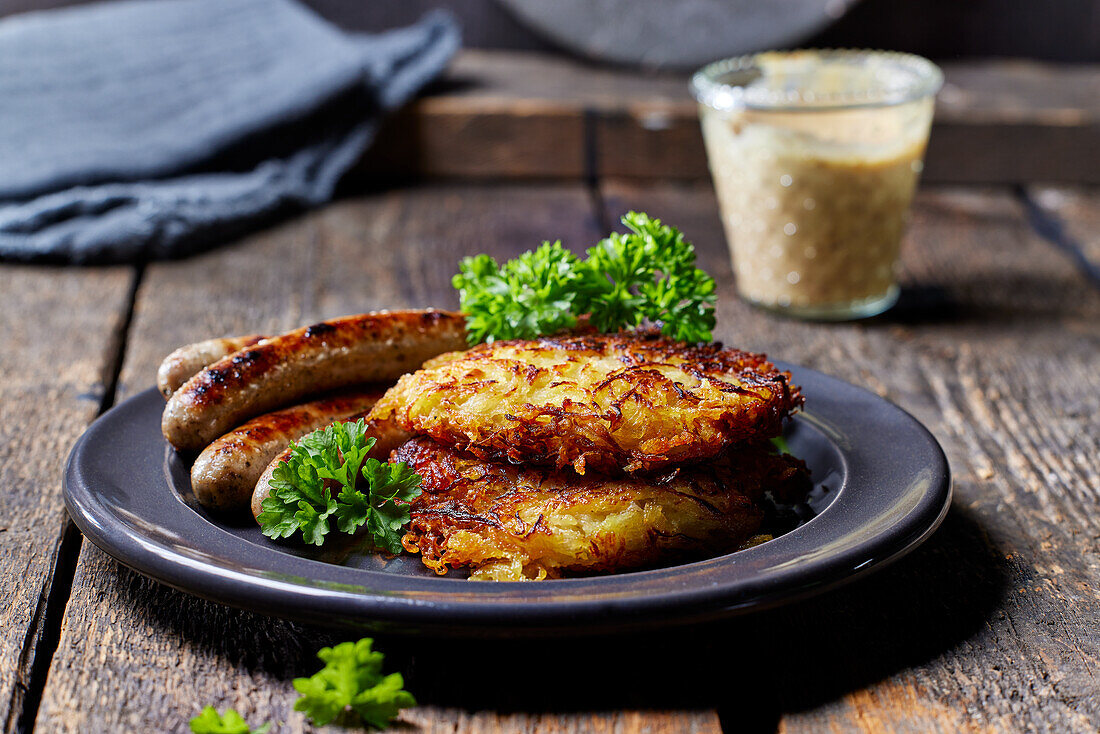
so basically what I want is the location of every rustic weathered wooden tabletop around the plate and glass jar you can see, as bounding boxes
[0,50,1100,733]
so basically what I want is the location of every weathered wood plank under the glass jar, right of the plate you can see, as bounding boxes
[605,179,1100,732]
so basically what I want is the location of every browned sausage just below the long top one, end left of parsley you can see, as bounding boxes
[191,388,383,513]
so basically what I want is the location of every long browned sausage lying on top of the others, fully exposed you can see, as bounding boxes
[161,309,466,451]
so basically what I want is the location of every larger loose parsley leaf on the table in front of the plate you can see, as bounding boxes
[294,637,416,728]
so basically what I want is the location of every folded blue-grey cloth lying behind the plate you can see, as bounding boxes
[0,0,459,263]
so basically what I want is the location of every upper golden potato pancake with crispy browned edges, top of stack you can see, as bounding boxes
[372,331,802,474]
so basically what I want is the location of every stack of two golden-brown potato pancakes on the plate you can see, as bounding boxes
[370,331,809,581]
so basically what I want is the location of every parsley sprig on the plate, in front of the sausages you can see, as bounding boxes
[259,419,421,555]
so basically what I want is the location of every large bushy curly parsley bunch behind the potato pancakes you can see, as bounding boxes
[453,211,715,343]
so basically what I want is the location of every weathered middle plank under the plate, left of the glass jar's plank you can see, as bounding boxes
[37,186,719,734]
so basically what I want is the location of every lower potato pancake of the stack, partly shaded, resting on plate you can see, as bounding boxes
[391,437,809,581]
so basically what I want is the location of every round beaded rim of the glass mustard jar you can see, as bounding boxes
[691,48,944,111]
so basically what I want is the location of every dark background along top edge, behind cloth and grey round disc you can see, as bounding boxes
[0,0,1100,62]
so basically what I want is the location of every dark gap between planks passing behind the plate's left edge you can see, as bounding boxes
[4,263,145,734]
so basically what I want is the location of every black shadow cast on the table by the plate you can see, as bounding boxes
[128,505,1007,732]
